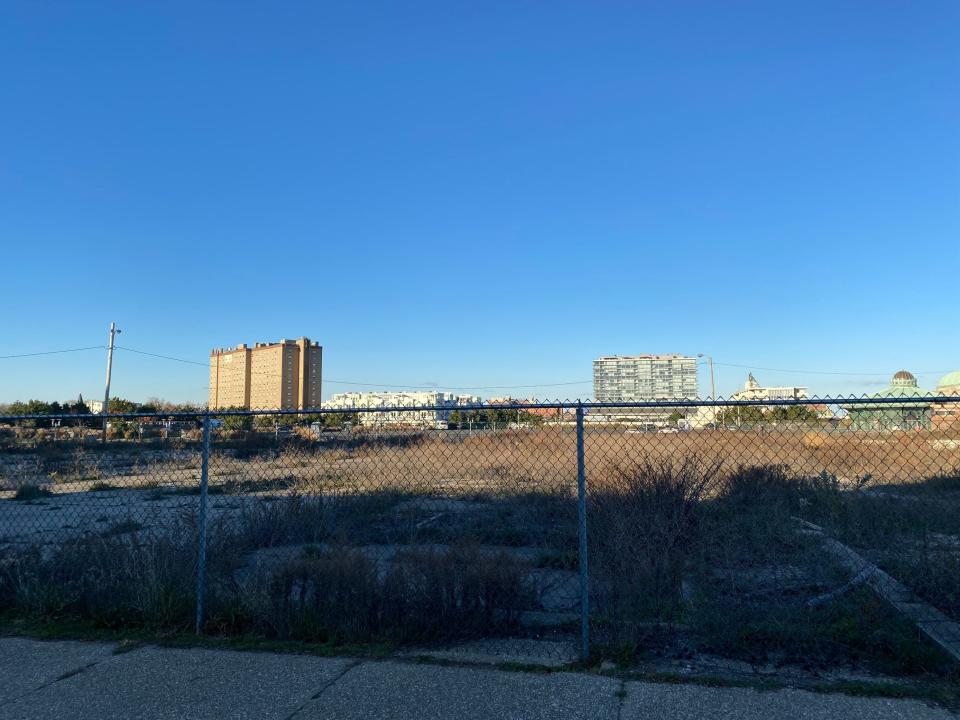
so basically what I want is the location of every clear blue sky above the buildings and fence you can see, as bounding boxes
[0,0,960,401]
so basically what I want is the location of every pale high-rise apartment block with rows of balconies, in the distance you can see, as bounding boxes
[593,354,699,402]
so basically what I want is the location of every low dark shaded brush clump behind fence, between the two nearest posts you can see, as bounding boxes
[224,546,530,643]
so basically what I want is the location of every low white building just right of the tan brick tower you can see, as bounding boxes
[323,390,481,428]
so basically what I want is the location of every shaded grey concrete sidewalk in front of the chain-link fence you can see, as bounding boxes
[0,638,955,720]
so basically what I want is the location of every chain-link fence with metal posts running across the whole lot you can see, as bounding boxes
[0,397,960,675]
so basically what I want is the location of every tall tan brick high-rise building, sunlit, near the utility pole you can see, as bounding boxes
[208,337,323,410]
